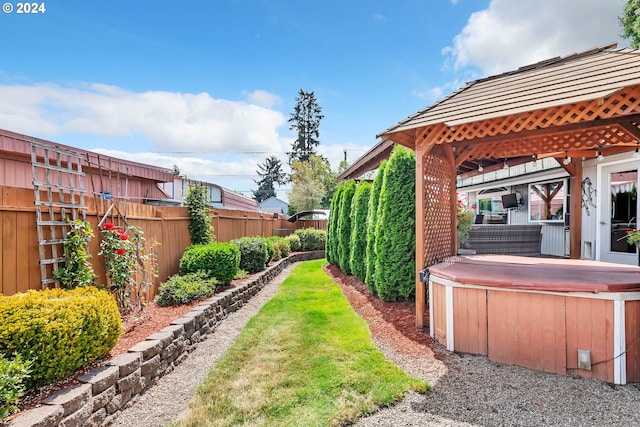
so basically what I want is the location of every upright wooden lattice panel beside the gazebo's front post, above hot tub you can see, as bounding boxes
[417,145,456,266]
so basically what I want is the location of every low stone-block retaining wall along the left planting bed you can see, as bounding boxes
[9,251,325,427]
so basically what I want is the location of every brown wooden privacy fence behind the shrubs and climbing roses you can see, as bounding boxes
[0,186,326,299]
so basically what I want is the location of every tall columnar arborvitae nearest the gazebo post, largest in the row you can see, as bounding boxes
[375,146,416,301]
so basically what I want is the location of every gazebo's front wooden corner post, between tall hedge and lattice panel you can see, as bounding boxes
[415,145,426,328]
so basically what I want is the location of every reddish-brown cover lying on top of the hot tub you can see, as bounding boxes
[429,255,640,293]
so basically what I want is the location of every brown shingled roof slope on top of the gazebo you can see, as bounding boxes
[378,44,640,136]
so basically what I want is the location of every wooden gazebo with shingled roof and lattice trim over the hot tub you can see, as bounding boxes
[339,44,640,327]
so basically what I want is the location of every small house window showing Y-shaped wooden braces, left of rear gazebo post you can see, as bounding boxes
[529,180,566,221]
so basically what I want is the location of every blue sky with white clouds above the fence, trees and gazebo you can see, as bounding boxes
[0,0,628,199]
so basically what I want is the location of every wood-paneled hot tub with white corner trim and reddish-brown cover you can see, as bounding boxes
[429,255,640,384]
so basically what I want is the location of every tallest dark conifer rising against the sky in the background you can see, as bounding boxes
[289,89,324,164]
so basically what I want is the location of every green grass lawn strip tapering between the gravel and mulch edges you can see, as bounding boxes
[176,260,429,426]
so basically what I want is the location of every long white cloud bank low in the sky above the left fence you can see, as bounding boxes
[0,84,288,153]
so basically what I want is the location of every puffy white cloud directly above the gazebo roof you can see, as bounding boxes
[444,0,626,75]
